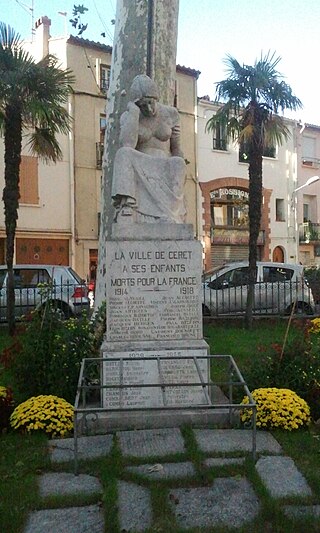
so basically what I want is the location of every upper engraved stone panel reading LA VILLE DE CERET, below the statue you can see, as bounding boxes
[106,241,202,341]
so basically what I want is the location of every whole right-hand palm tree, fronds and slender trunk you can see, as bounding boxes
[206,52,302,327]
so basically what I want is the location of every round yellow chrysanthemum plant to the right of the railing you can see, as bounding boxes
[241,387,310,431]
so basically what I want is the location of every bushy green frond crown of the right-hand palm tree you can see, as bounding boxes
[206,51,302,150]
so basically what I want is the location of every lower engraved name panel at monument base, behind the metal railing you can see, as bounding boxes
[103,349,209,409]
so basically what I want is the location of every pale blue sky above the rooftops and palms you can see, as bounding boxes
[0,0,320,125]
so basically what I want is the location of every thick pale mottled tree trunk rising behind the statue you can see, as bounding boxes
[95,0,179,309]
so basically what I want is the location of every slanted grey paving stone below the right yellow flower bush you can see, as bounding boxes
[256,456,312,498]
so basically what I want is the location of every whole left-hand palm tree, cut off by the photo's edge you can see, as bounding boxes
[0,22,73,334]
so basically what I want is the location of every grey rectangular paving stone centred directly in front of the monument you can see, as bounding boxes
[117,428,185,457]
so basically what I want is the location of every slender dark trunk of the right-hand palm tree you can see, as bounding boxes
[245,150,262,329]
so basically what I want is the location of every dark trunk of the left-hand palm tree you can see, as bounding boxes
[3,106,22,335]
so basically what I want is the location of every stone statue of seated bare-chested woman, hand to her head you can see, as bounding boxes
[112,75,186,223]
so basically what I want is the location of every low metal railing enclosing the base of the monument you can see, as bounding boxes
[74,355,256,474]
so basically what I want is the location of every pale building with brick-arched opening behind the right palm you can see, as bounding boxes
[198,97,299,270]
